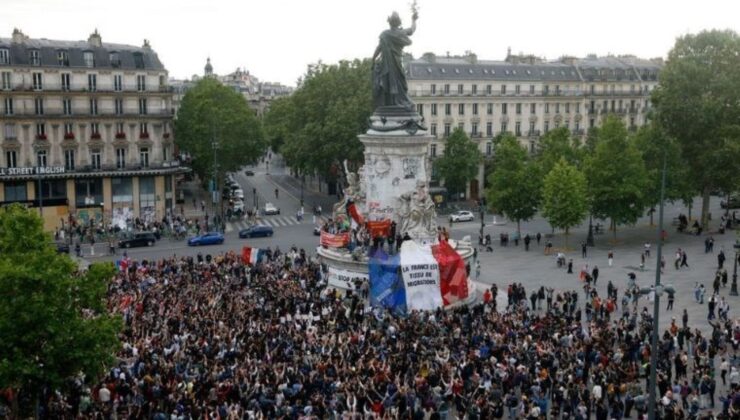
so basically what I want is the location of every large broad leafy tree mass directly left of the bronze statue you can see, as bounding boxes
[264,60,374,180]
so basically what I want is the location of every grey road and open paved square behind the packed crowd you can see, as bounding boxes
[83,162,739,331]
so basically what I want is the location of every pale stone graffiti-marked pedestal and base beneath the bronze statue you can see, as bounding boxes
[317,112,478,304]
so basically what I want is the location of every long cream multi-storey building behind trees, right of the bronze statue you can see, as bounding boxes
[407,53,662,199]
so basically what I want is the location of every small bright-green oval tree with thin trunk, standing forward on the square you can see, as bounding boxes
[542,158,588,248]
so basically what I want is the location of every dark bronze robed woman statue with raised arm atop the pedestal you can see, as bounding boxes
[373,2,419,112]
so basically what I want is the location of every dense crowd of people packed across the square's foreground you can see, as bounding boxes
[13,233,740,420]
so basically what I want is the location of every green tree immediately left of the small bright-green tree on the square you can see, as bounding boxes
[486,134,542,234]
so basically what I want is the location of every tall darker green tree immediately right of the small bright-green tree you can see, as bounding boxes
[585,116,650,240]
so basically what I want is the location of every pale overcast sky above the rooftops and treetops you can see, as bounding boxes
[0,0,740,85]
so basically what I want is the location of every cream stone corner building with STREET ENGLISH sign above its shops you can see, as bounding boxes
[0,29,187,229]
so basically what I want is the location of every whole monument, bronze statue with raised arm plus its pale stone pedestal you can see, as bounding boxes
[318,4,473,295]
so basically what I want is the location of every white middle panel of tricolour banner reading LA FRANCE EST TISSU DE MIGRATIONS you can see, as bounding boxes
[401,241,442,311]
